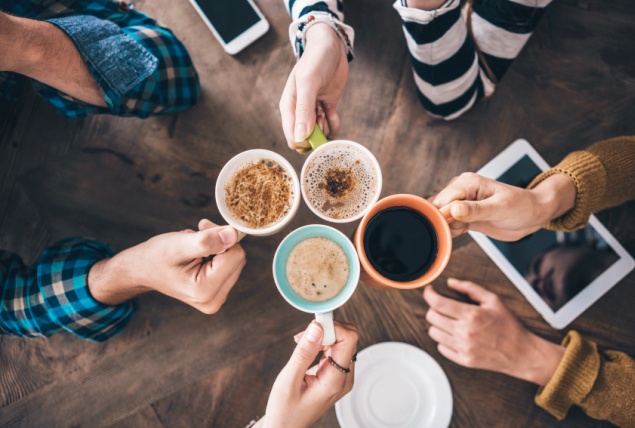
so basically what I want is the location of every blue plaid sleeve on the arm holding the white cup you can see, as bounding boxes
[0,238,136,342]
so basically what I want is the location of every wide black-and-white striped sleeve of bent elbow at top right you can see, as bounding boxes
[393,0,550,120]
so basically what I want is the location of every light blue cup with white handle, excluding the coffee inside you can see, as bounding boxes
[273,224,359,345]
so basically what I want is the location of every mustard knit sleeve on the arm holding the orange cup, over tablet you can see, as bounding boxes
[528,136,635,231]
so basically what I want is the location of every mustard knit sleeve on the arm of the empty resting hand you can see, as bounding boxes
[535,331,635,427]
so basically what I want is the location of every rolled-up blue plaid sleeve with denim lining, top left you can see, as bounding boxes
[0,0,200,118]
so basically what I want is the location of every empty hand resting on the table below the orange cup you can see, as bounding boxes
[423,279,564,385]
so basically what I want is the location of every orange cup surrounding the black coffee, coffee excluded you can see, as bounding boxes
[353,194,452,289]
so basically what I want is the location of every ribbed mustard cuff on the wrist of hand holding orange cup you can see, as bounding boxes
[527,151,607,231]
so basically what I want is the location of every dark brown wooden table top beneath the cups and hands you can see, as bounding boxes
[0,0,635,427]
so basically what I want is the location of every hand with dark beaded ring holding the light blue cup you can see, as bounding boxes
[256,322,357,428]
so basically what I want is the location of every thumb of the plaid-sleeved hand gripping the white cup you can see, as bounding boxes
[174,226,238,259]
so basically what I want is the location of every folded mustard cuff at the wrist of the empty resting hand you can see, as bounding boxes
[534,331,600,420]
